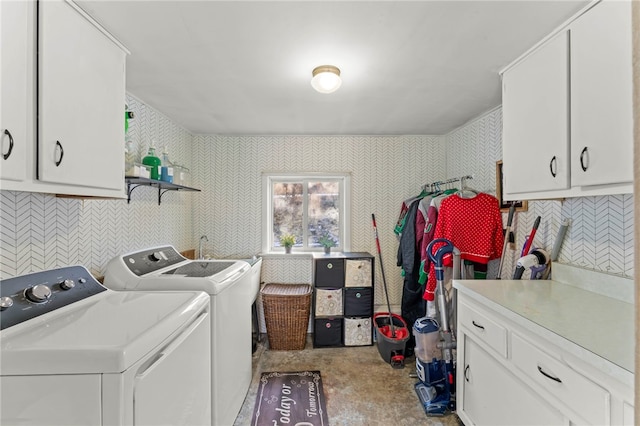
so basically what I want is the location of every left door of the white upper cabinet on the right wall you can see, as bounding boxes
[502,32,570,194]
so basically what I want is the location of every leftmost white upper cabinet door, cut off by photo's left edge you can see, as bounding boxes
[0,1,28,181]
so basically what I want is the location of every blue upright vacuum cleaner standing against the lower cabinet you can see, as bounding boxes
[413,238,460,416]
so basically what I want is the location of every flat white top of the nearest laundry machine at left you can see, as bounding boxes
[0,291,209,376]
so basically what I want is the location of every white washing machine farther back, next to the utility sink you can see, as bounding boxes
[104,245,255,426]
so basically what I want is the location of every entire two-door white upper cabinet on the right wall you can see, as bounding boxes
[502,0,633,200]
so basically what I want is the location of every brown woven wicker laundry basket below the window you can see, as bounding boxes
[260,283,312,351]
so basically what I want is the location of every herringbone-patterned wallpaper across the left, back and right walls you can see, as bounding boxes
[0,96,634,304]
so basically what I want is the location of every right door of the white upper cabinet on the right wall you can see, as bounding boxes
[569,1,633,186]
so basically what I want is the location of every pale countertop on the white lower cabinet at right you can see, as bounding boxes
[453,280,635,384]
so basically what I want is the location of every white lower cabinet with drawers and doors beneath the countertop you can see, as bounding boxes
[456,293,633,426]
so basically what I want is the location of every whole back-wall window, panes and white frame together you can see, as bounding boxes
[263,174,350,252]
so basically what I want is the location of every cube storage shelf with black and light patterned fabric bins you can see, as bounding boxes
[313,252,375,348]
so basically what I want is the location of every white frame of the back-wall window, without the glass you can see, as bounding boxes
[262,172,351,253]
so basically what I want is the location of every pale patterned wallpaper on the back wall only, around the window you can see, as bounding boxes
[193,135,446,304]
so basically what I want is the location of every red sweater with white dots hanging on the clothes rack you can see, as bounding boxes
[423,192,504,301]
